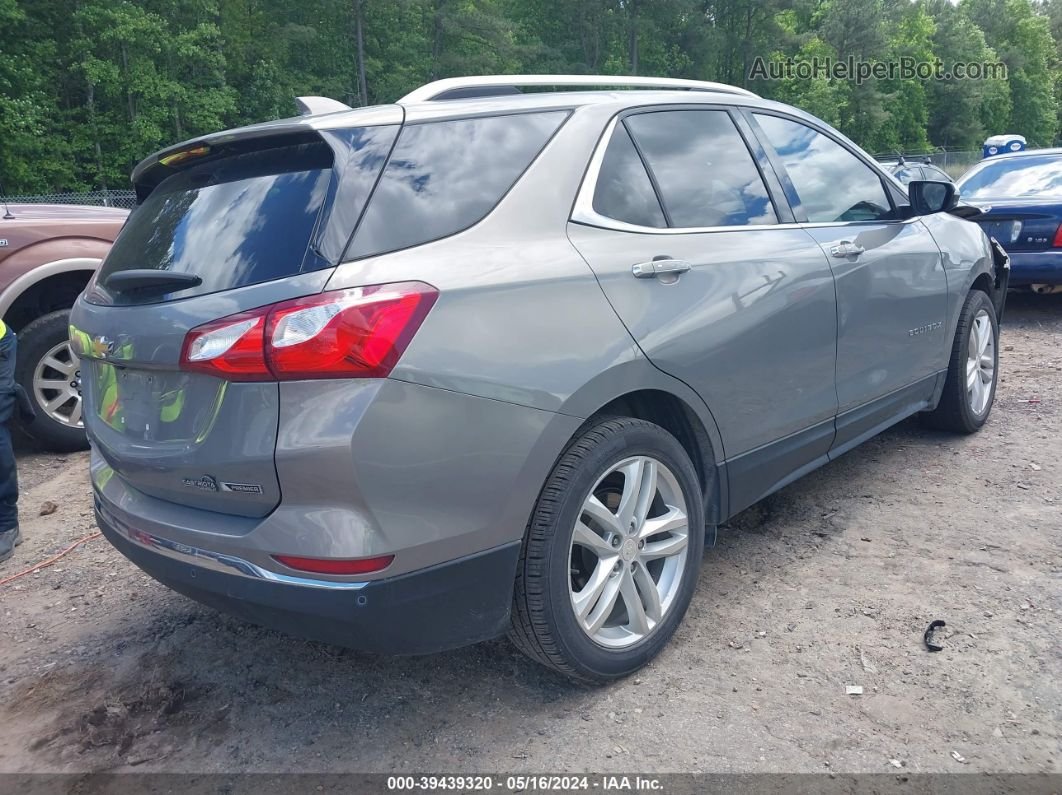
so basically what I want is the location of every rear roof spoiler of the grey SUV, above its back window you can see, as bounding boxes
[132,102,406,203]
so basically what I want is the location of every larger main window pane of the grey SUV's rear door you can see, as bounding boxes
[626,110,778,227]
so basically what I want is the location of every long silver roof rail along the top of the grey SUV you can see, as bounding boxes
[398,74,756,104]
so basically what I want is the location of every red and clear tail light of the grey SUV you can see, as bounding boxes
[181,281,439,381]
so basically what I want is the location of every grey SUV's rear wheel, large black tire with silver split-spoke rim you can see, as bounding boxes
[510,418,704,682]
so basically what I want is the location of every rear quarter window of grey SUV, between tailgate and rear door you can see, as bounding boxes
[345,111,568,259]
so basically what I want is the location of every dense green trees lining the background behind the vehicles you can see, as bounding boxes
[0,0,1062,193]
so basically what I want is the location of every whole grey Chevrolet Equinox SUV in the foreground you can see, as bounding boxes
[71,75,1006,681]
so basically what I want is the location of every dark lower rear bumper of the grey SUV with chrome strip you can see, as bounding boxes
[96,496,520,654]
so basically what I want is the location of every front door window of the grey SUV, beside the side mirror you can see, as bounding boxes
[756,114,894,223]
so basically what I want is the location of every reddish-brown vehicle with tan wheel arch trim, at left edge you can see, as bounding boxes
[0,204,129,452]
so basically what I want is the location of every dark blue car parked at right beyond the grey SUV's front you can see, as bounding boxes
[958,149,1062,292]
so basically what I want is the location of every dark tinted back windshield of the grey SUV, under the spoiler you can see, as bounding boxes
[91,125,397,304]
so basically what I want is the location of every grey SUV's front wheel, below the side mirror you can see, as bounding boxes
[923,290,999,433]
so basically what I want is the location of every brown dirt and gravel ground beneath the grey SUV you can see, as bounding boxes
[0,295,1062,773]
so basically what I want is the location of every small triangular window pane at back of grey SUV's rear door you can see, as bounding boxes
[594,124,667,227]
